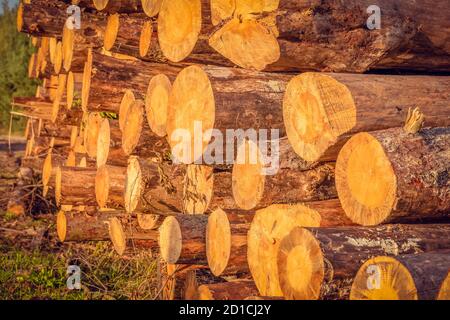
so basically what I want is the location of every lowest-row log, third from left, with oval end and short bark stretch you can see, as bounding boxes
[159,214,208,265]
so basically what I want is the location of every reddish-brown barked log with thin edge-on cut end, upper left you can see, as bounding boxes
[82,52,179,113]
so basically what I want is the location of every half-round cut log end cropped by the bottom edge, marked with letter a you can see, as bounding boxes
[350,256,418,300]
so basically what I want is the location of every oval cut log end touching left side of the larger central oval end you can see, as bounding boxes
[145,74,172,137]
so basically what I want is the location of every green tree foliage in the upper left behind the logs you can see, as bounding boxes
[0,0,37,134]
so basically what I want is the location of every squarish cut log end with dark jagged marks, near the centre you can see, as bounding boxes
[183,165,214,214]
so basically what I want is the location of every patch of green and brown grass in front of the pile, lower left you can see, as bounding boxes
[0,242,158,300]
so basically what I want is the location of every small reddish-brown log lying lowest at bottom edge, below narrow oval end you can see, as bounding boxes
[198,280,259,300]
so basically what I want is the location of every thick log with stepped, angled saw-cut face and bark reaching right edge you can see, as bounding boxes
[283,73,450,161]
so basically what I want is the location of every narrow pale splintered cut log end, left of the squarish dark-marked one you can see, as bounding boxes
[125,157,143,213]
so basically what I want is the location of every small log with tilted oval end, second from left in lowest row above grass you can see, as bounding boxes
[109,215,158,256]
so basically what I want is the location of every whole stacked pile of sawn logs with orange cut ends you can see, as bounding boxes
[11,0,450,300]
